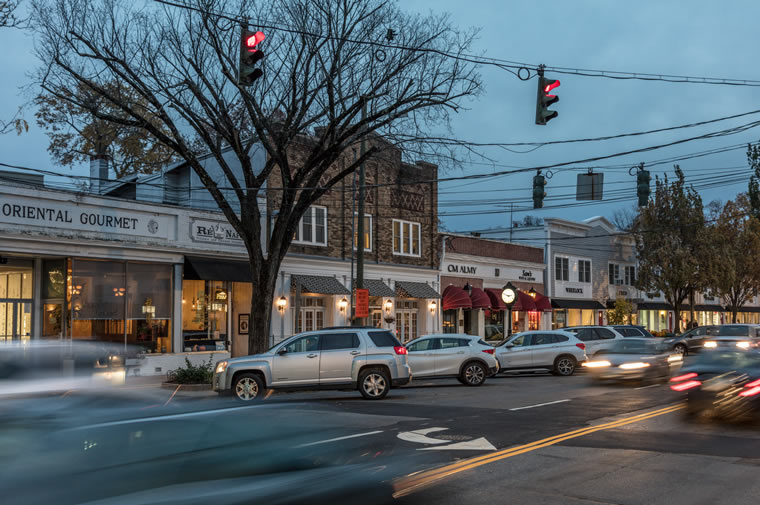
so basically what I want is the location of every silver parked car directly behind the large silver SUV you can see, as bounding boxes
[406,334,499,386]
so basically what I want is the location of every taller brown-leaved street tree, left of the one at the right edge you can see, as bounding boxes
[633,165,708,332]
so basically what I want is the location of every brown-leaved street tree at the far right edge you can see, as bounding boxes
[708,194,760,323]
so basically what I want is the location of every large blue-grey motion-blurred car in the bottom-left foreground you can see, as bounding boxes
[0,390,411,505]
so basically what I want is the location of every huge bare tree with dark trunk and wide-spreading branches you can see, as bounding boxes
[33,0,481,352]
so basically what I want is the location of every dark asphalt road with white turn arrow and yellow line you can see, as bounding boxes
[150,368,760,505]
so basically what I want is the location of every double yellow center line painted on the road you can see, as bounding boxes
[393,404,684,498]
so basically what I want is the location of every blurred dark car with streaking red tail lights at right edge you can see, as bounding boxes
[670,348,760,420]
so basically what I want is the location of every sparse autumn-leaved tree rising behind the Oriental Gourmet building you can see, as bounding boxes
[35,82,176,177]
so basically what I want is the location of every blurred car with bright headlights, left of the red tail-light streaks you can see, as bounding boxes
[583,338,683,382]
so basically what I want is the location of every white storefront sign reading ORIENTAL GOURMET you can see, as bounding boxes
[0,194,170,239]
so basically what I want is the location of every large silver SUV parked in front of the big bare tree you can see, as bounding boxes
[213,327,412,401]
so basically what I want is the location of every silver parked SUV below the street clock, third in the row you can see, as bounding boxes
[496,330,586,375]
